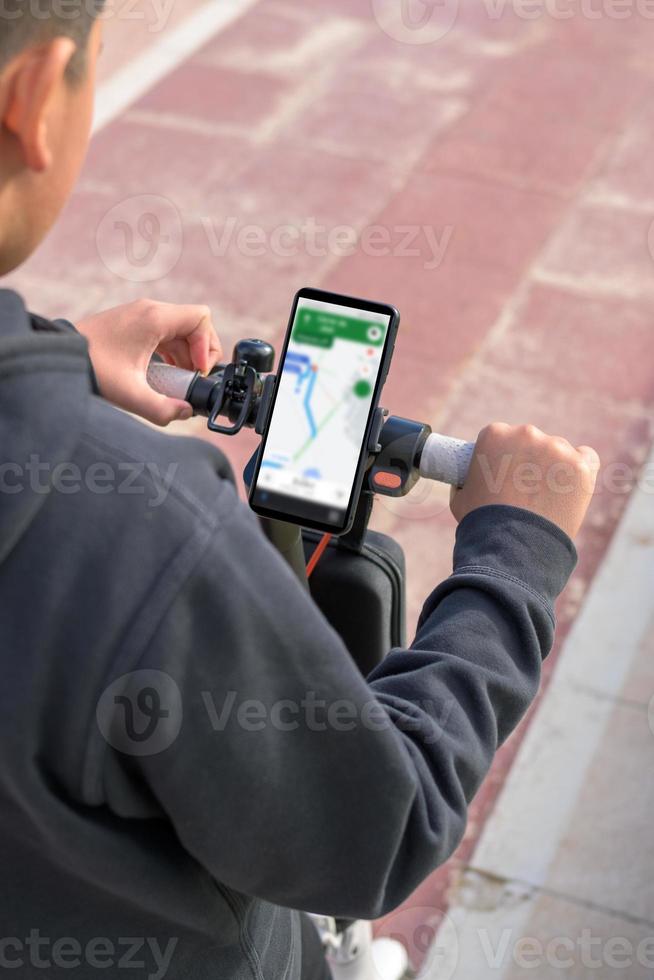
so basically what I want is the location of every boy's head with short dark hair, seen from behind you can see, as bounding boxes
[0,0,102,275]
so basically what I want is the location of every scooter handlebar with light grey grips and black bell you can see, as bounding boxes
[148,350,475,496]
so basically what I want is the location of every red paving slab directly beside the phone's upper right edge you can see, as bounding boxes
[326,174,563,421]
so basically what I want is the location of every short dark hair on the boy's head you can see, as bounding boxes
[0,0,104,81]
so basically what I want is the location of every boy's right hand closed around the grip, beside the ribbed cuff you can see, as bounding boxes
[451,422,600,538]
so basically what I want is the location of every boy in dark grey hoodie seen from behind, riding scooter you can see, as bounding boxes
[0,0,598,980]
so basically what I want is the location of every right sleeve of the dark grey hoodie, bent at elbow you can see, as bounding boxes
[115,506,576,918]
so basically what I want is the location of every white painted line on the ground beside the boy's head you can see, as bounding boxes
[93,0,258,132]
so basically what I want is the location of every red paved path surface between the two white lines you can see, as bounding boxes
[7,0,654,963]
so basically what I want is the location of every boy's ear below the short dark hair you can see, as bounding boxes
[0,37,75,173]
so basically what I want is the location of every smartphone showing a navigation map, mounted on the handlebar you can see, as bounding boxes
[249,288,400,534]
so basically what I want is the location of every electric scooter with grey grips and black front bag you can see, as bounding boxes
[148,340,474,980]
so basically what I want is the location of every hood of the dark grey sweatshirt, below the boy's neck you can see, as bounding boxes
[0,289,91,563]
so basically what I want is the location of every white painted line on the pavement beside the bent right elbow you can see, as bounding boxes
[421,454,654,980]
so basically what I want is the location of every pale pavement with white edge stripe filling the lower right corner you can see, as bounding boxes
[426,455,654,980]
